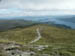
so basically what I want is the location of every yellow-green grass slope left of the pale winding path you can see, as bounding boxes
[0,28,36,44]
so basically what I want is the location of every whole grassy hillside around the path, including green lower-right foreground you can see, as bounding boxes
[0,24,75,56]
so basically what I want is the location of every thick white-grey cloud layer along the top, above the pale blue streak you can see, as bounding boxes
[0,0,75,10]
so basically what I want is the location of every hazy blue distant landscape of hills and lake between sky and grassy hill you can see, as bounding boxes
[0,15,75,31]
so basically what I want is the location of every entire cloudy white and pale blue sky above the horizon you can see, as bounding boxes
[0,0,75,16]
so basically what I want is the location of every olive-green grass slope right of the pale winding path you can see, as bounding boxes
[34,25,75,44]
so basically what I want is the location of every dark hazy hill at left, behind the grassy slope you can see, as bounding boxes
[0,19,36,31]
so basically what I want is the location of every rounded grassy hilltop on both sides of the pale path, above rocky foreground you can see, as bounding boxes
[0,24,75,44]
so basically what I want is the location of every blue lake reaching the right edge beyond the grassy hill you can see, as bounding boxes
[47,19,75,29]
